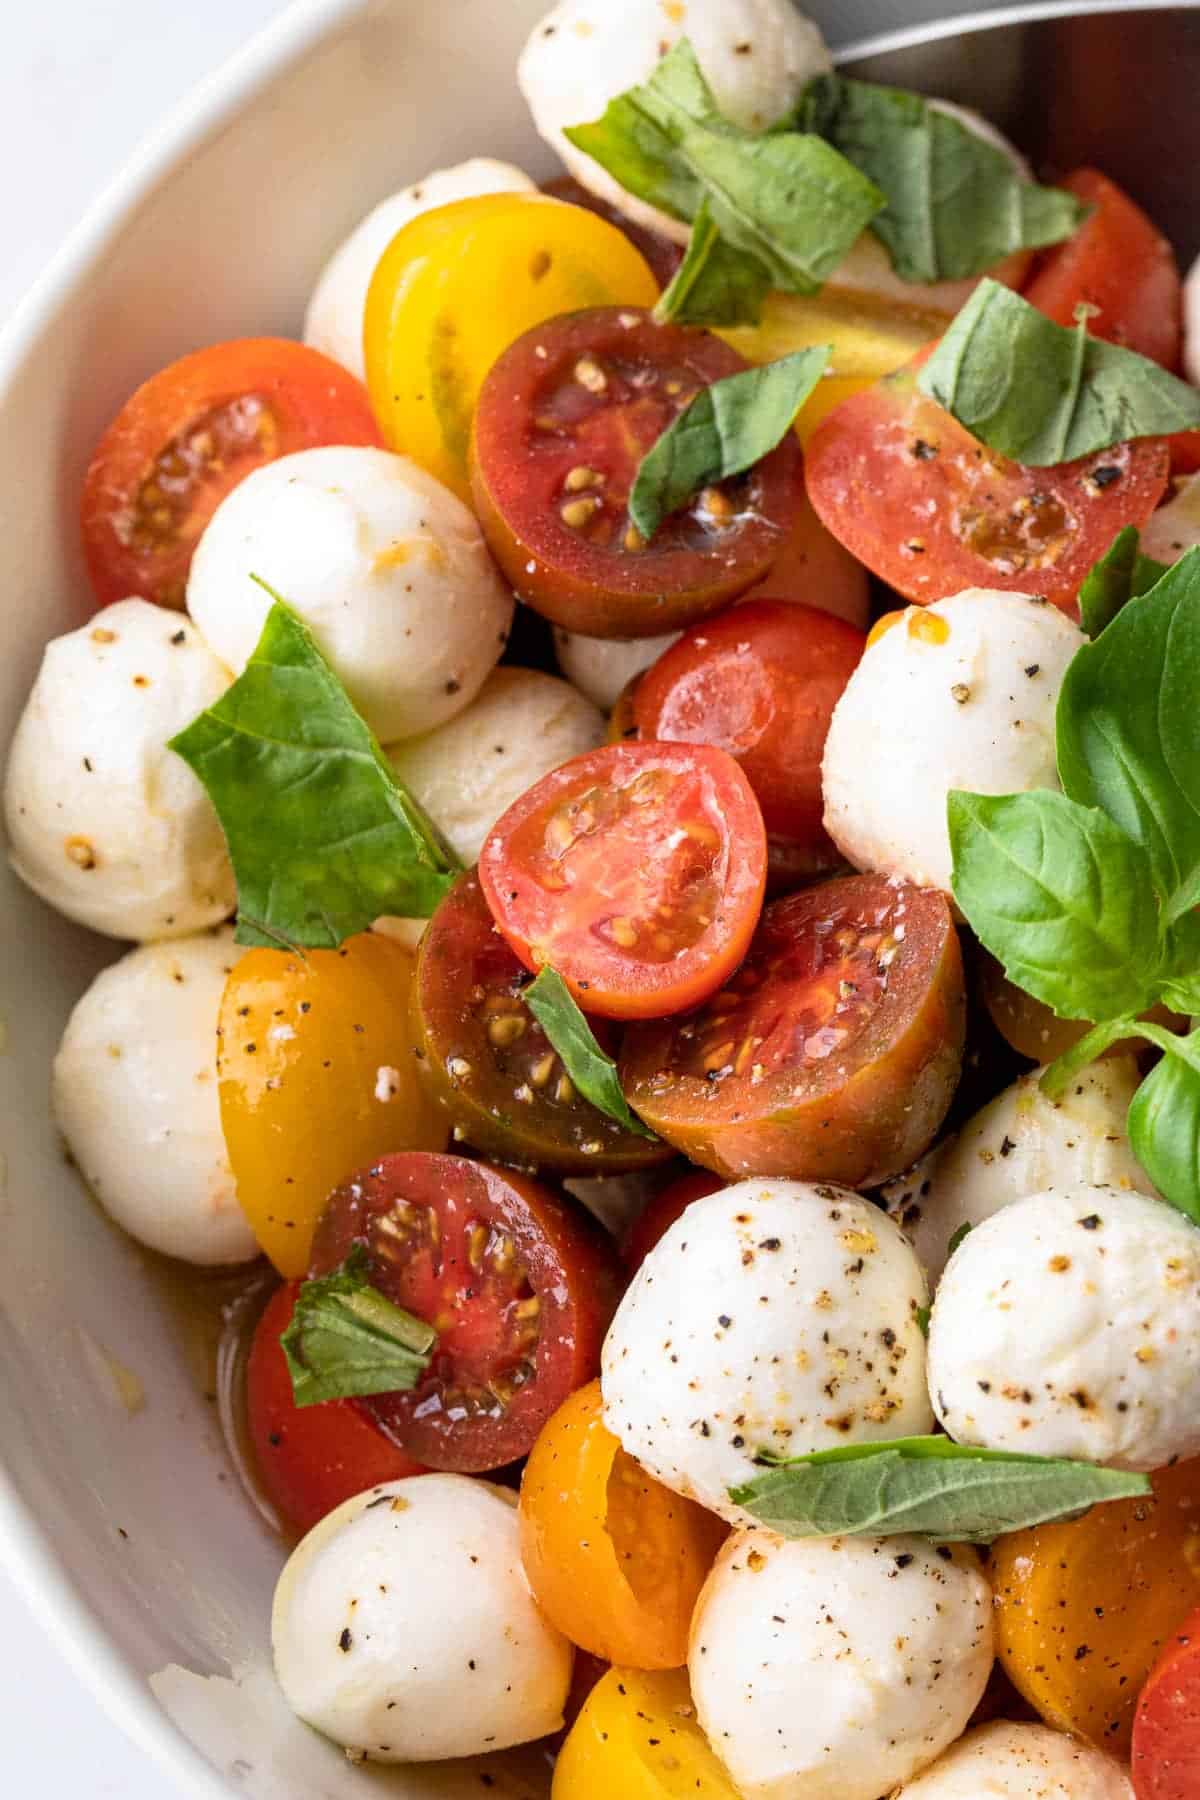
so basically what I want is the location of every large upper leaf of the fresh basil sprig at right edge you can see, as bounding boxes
[1058,549,1200,921]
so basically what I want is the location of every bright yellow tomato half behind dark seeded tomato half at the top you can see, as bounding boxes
[363,194,658,502]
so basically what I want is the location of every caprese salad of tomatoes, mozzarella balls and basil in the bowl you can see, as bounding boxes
[5,0,1200,1800]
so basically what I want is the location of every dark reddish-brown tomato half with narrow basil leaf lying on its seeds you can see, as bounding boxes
[471,306,801,637]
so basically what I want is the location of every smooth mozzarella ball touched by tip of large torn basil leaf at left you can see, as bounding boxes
[187,448,513,743]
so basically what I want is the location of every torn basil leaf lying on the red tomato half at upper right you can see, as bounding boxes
[918,281,1200,468]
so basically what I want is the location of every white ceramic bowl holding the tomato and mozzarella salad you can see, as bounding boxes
[0,0,1194,1800]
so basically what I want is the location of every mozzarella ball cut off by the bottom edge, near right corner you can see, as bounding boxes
[894,1719,1133,1800]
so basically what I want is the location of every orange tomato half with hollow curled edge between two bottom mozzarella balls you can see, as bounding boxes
[520,1381,727,1669]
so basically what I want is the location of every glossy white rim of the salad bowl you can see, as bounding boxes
[0,0,1200,1800]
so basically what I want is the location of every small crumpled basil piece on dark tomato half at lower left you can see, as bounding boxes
[279,1244,437,1406]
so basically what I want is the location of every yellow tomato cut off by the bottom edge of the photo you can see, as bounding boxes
[551,1669,738,1800]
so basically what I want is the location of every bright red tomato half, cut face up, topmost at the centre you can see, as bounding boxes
[479,743,766,1019]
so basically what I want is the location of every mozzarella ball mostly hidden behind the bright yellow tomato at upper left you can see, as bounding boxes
[304,157,534,382]
